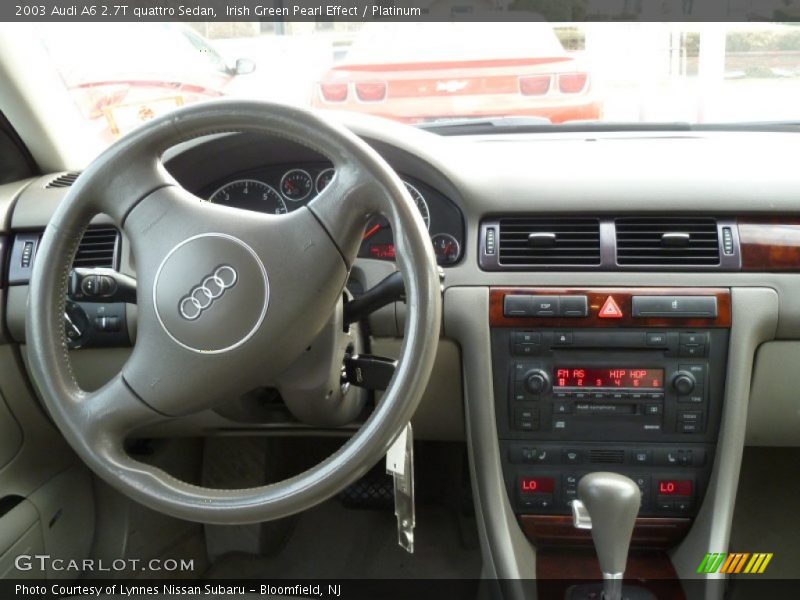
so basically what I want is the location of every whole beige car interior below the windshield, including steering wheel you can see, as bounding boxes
[0,16,800,600]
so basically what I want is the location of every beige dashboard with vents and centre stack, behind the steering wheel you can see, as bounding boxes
[0,116,800,578]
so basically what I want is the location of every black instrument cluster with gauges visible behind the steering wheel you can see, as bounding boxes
[199,161,464,267]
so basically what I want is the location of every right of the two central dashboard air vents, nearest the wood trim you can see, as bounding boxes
[616,217,720,267]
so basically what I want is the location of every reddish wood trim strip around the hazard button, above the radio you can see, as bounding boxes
[489,287,731,328]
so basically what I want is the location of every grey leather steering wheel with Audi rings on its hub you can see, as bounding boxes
[26,101,441,524]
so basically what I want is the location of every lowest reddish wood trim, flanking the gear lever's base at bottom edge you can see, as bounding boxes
[536,549,686,600]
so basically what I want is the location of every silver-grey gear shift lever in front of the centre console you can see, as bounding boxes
[572,472,641,600]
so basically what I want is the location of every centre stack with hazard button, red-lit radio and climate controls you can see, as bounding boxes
[490,288,731,532]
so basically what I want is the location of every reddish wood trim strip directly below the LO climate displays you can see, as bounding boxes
[519,515,692,550]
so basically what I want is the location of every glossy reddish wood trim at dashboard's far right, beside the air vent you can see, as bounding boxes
[739,217,800,272]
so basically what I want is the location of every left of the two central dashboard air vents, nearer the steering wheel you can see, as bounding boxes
[499,217,600,267]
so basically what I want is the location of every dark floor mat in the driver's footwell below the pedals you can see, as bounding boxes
[205,501,481,579]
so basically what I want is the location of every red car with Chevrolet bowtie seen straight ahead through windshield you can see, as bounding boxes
[312,23,602,123]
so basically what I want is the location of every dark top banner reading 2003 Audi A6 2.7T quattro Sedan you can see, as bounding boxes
[6,0,800,22]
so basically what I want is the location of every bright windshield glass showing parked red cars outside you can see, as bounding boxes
[28,22,800,143]
